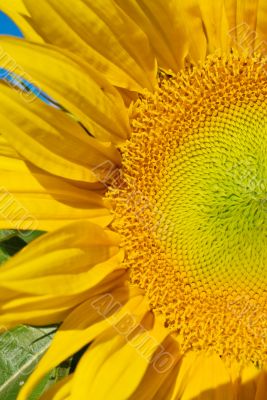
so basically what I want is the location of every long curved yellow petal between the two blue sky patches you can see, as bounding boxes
[0,38,130,141]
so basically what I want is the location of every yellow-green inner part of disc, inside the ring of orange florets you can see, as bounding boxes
[157,104,267,293]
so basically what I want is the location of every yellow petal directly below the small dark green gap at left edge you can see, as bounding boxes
[0,221,122,297]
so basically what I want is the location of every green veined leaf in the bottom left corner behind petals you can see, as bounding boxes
[0,326,55,400]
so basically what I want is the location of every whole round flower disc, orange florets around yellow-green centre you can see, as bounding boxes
[110,56,267,365]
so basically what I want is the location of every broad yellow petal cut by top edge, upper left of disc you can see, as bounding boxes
[25,0,156,91]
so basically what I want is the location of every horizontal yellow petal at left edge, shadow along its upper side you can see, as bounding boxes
[0,155,112,234]
